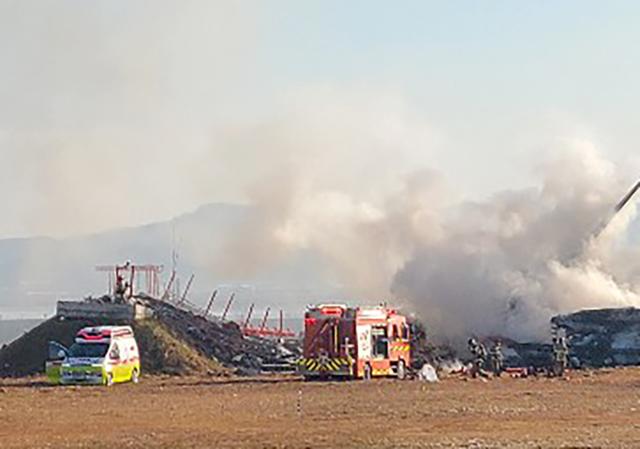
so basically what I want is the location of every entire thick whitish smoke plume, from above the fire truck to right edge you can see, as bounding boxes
[236,138,640,340]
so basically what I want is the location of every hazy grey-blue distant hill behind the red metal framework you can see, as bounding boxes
[0,204,338,320]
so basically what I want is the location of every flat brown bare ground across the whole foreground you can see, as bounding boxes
[0,369,640,449]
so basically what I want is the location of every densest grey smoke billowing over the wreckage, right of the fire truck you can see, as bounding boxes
[393,147,640,340]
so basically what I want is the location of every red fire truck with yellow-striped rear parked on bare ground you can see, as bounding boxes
[298,304,411,379]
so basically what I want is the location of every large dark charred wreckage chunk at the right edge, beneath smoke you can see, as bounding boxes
[551,308,640,367]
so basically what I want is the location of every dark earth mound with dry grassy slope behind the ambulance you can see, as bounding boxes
[0,297,299,377]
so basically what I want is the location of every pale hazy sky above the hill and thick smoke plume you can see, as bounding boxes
[0,0,640,237]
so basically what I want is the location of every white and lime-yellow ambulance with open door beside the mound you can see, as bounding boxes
[46,326,140,386]
